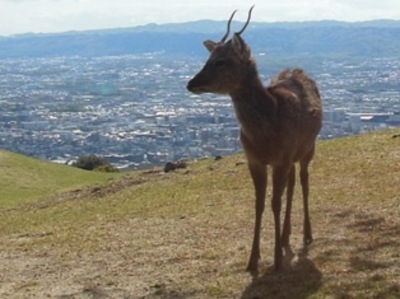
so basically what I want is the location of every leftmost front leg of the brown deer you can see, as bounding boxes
[247,161,267,273]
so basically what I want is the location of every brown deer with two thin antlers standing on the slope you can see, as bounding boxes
[187,6,322,273]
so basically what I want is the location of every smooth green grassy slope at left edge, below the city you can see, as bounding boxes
[0,150,118,208]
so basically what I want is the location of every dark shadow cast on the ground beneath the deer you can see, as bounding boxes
[240,247,322,299]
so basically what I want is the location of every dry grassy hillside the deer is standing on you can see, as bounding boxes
[0,129,400,299]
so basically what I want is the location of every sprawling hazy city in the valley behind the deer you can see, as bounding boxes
[0,53,400,168]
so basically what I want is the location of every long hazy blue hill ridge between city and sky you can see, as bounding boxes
[0,20,400,59]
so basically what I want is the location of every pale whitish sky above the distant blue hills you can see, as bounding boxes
[0,0,400,36]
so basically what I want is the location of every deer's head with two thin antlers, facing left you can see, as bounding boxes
[187,5,254,94]
